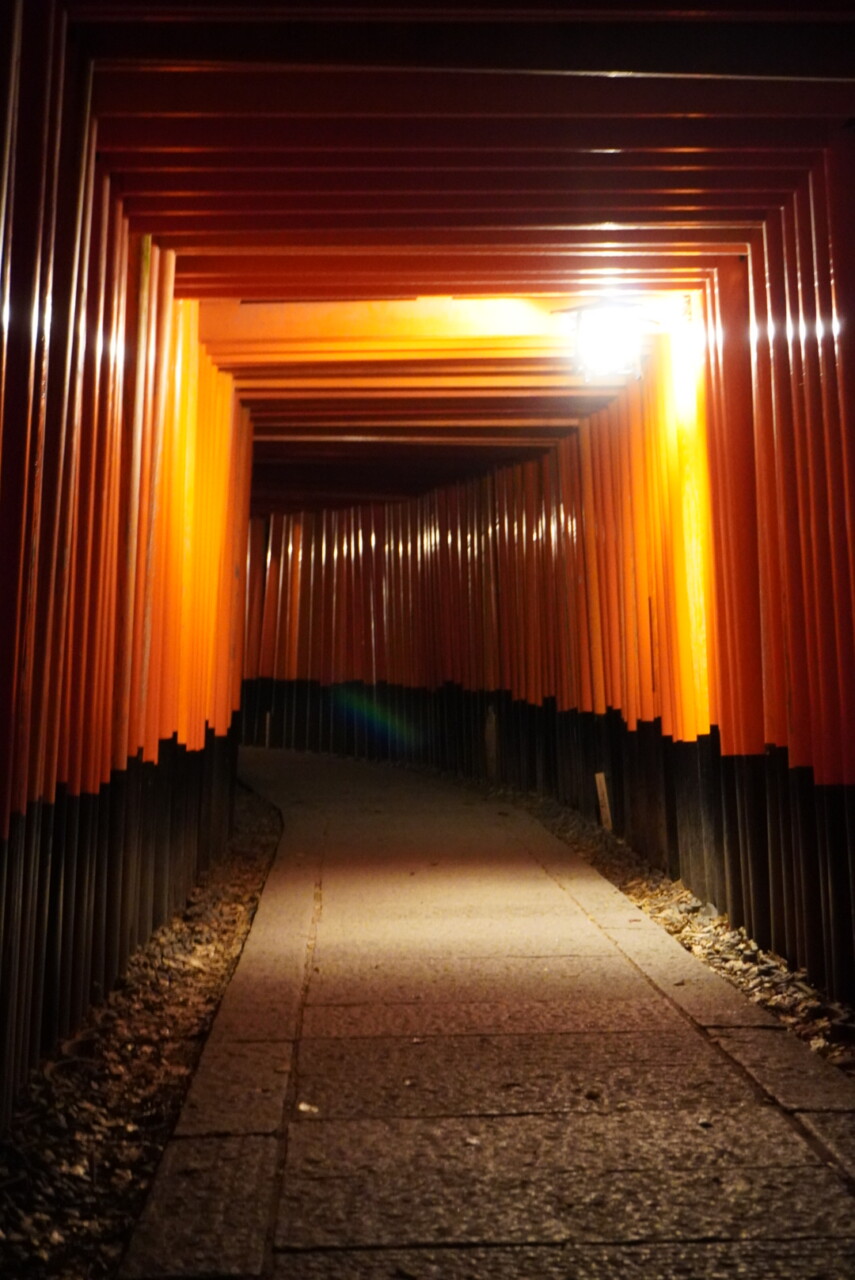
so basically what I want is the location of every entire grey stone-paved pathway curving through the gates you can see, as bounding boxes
[123,750,855,1280]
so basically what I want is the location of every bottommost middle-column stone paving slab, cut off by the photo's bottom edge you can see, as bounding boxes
[275,1240,855,1280]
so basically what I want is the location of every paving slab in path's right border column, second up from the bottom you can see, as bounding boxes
[714,1028,855,1112]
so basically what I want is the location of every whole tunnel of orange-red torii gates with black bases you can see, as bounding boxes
[0,0,855,1111]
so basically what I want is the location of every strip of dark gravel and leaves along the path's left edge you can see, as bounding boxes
[0,787,282,1280]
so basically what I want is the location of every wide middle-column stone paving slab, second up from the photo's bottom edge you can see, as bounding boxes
[275,1166,855,1248]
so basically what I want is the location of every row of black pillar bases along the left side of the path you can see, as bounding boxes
[0,718,238,1121]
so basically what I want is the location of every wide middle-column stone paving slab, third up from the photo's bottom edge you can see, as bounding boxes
[285,1106,820,1183]
